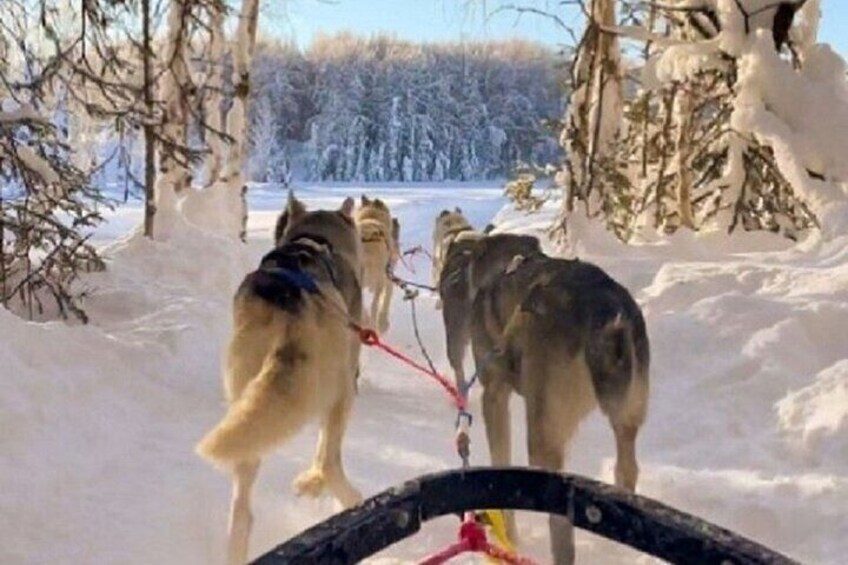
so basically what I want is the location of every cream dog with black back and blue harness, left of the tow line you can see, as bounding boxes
[197,194,362,565]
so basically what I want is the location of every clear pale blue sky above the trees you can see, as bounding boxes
[262,0,848,56]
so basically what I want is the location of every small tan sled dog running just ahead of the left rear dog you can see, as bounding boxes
[354,195,400,334]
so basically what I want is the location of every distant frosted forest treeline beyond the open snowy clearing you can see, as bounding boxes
[245,34,565,182]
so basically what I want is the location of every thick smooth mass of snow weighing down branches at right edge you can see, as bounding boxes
[732,32,848,233]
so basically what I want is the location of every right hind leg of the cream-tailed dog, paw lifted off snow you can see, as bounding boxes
[294,386,362,508]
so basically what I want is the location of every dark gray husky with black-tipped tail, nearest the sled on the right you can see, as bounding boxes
[471,254,650,564]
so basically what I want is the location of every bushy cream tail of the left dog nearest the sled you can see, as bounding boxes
[196,344,312,468]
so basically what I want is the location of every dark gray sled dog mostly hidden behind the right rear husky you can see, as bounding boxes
[438,234,542,390]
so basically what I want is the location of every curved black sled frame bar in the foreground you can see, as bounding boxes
[253,467,797,565]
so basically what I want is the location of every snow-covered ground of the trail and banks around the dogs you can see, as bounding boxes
[0,185,848,565]
